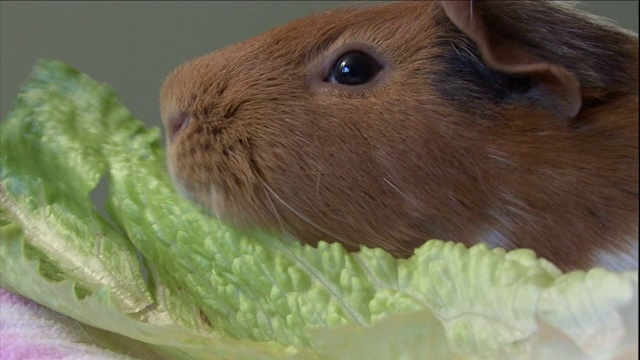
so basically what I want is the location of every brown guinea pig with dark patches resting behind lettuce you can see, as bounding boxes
[161,1,638,270]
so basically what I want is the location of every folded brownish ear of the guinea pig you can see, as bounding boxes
[441,0,582,119]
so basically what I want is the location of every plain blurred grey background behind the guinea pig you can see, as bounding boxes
[0,1,638,132]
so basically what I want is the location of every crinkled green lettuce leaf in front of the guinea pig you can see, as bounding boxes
[0,60,638,359]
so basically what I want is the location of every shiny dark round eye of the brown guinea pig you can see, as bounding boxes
[325,51,381,85]
